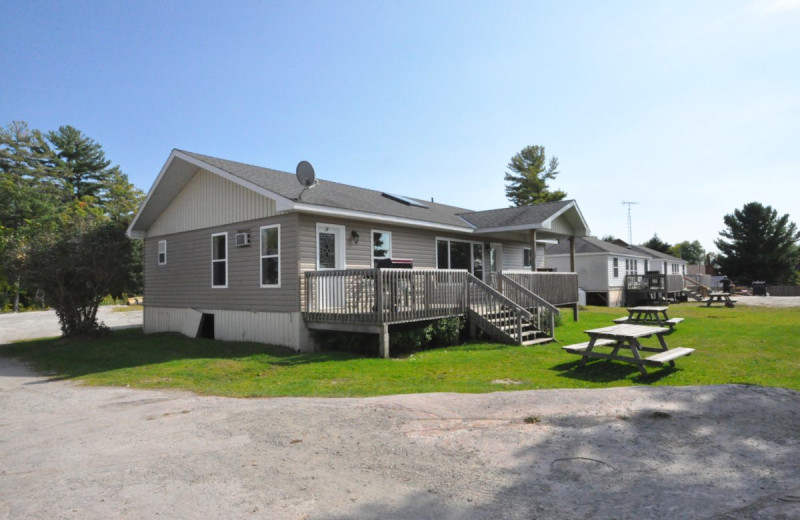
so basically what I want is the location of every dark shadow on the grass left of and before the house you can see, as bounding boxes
[0,329,358,381]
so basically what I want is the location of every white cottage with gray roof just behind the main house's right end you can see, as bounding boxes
[545,236,651,307]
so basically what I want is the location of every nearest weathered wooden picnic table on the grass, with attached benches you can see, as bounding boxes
[562,324,694,376]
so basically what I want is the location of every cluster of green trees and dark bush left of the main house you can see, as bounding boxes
[0,121,144,335]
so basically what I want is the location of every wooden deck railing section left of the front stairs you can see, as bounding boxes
[305,269,468,324]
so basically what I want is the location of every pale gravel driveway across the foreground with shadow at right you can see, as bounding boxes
[0,358,800,520]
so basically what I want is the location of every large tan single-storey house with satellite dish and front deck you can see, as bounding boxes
[128,150,588,354]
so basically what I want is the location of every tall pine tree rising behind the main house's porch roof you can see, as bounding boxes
[505,146,567,206]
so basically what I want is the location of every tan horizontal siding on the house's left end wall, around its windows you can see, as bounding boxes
[144,214,300,312]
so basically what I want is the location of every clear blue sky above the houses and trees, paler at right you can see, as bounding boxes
[0,0,800,249]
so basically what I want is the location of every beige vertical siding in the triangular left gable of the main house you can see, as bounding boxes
[147,170,276,237]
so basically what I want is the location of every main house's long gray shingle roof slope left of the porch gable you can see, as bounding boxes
[178,150,471,230]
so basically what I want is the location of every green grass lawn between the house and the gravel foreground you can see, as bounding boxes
[0,303,800,397]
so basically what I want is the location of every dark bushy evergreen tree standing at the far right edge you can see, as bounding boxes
[714,202,800,284]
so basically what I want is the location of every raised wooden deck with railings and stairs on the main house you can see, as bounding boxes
[303,269,577,354]
